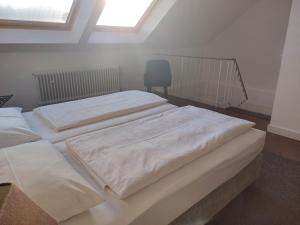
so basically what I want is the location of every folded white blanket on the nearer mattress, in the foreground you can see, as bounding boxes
[66,106,254,198]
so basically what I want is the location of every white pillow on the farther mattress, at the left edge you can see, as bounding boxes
[0,108,41,148]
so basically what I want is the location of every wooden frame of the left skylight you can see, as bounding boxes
[0,0,79,30]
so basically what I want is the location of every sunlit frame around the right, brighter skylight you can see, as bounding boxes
[95,0,159,32]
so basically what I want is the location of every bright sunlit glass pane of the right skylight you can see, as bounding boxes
[97,0,154,28]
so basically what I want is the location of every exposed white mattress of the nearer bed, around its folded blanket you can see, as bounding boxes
[55,129,265,225]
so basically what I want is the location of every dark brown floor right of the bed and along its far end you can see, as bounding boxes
[166,94,300,225]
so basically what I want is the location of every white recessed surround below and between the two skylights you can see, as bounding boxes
[0,0,176,44]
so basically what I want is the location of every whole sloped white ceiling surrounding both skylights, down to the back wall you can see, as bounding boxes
[0,0,259,47]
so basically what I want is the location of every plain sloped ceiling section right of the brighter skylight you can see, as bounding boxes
[145,0,259,48]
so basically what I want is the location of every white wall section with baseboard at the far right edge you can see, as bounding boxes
[269,0,300,140]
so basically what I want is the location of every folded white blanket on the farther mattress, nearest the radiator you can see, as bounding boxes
[34,91,167,131]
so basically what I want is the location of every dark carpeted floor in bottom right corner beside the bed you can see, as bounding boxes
[173,152,300,225]
